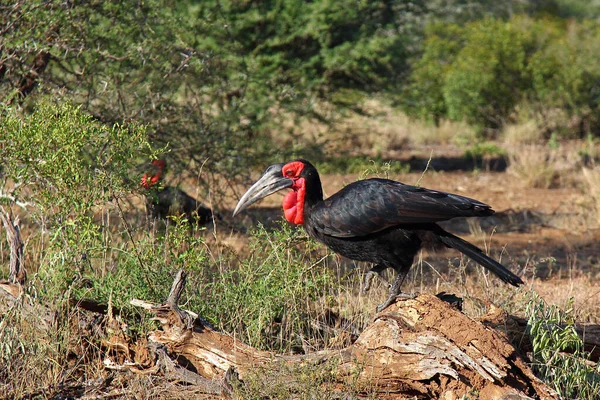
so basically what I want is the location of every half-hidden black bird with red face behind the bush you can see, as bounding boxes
[140,160,220,225]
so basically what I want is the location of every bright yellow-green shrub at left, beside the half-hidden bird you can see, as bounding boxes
[0,100,162,297]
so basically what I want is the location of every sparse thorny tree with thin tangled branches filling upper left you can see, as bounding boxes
[0,0,276,189]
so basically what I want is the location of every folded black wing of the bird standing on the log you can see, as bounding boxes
[310,179,494,237]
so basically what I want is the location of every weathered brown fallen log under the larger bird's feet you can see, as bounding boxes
[132,271,557,399]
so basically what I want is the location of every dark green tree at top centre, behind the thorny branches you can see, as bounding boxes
[205,0,412,94]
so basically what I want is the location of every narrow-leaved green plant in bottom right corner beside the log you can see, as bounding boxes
[526,294,600,400]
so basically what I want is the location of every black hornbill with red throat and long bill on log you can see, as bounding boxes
[233,159,523,312]
